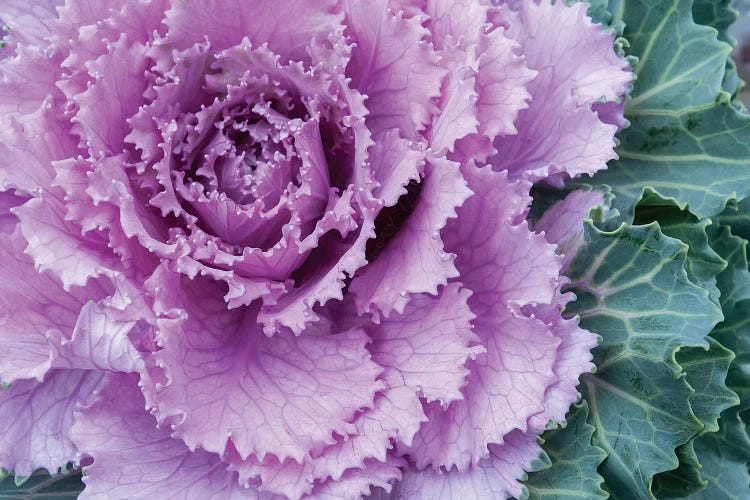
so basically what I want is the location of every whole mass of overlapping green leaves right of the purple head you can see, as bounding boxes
[527,0,750,499]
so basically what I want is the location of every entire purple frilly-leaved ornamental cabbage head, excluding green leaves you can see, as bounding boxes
[0,0,632,499]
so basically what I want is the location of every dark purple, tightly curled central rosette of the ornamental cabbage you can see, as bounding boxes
[75,32,384,333]
